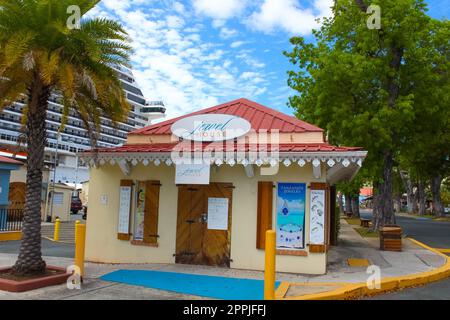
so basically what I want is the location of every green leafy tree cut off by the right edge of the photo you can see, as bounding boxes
[400,20,450,215]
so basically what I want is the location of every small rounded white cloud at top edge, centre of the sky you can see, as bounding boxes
[192,0,247,20]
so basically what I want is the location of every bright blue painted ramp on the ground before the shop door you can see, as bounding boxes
[100,270,280,300]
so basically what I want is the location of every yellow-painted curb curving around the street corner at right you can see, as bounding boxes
[275,238,450,300]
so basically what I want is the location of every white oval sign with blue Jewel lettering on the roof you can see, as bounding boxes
[171,113,252,142]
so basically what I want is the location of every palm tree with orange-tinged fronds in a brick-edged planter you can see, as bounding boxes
[0,0,131,275]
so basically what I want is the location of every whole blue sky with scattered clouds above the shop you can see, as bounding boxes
[90,0,450,118]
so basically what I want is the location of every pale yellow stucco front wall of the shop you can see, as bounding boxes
[86,164,326,274]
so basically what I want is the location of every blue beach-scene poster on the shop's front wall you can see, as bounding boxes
[277,183,306,249]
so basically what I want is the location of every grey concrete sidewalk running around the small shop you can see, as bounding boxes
[0,220,447,299]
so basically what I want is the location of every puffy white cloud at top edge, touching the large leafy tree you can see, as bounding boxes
[247,0,333,35]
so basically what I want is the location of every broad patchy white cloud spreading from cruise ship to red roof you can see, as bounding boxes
[90,0,268,118]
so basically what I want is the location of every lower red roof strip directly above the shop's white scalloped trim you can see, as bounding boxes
[90,142,362,153]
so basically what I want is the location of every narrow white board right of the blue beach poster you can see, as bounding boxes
[309,190,325,244]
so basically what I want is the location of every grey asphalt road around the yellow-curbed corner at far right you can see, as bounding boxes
[361,212,450,300]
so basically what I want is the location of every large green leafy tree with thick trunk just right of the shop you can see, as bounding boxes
[285,0,440,229]
